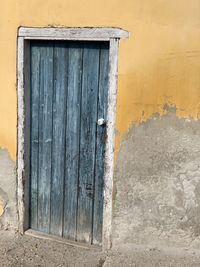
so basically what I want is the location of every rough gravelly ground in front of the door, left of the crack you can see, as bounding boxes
[0,230,105,267]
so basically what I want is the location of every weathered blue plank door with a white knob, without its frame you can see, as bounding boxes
[30,41,109,244]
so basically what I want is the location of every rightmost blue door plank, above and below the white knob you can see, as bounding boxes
[93,43,109,244]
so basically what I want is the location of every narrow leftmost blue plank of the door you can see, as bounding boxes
[30,44,40,229]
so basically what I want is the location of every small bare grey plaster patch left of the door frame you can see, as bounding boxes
[0,149,17,229]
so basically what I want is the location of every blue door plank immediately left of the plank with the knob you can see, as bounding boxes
[77,43,99,245]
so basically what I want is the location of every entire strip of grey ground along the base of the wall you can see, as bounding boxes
[0,231,200,267]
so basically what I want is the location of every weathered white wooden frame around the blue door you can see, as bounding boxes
[17,27,129,249]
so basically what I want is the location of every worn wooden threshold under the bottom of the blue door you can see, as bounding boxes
[25,229,102,250]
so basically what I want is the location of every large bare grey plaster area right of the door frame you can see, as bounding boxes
[113,110,200,247]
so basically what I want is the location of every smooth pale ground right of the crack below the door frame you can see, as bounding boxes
[103,244,200,267]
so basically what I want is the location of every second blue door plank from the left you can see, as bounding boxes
[38,42,53,233]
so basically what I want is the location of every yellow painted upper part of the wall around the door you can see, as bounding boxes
[0,0,200,159]
